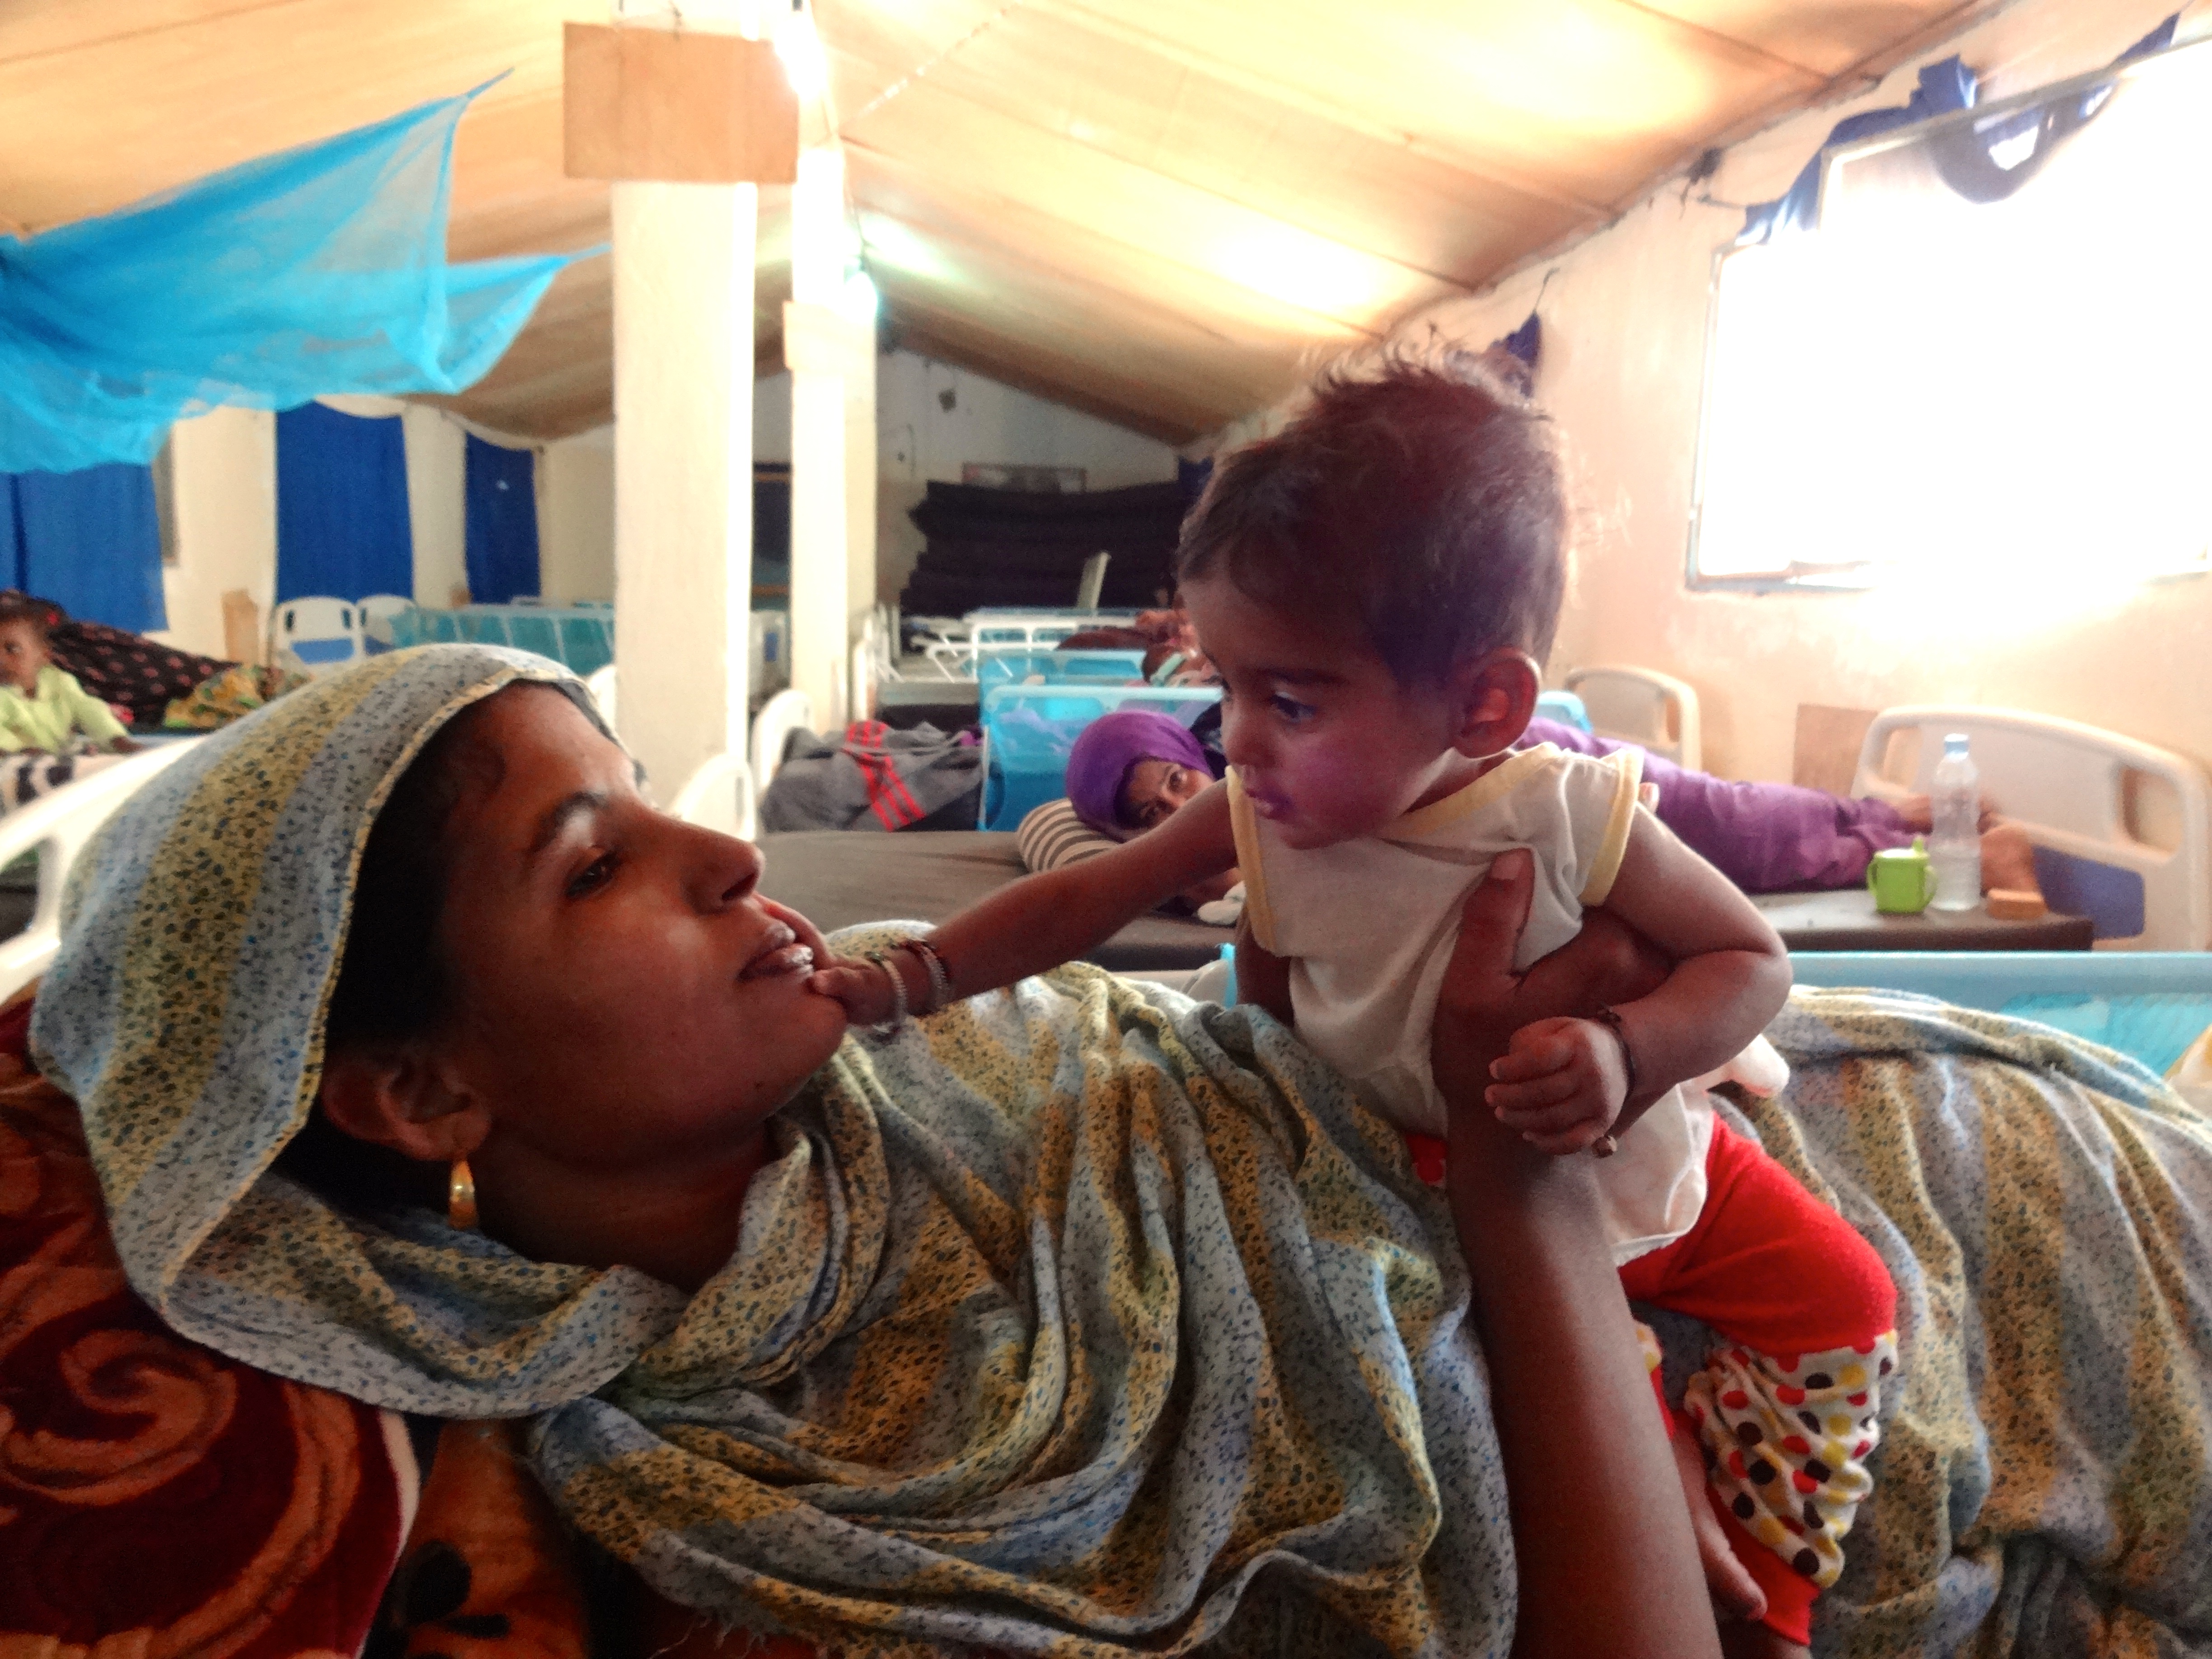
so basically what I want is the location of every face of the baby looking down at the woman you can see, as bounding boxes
[1183,577,1464,847]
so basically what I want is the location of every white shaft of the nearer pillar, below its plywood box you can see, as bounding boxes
[613,183,759,803]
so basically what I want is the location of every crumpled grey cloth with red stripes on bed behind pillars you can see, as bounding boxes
[761,721,982,830]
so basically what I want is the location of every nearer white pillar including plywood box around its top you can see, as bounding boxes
[564,0,798,801]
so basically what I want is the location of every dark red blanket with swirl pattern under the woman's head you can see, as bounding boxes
[0,1000,414,1659]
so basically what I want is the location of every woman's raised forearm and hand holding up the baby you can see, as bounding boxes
[1429,852,1719,1659]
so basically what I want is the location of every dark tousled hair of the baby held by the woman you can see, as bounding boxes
[1175,347,1566,684]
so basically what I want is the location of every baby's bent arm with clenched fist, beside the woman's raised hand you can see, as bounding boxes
[1484,812,1790,1153]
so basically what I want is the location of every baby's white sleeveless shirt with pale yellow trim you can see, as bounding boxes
[1230,743,1781,1263]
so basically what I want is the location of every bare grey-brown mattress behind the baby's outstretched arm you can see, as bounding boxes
[761,830,1234,971]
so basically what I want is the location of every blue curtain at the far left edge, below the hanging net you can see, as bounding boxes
[0,467,168,633]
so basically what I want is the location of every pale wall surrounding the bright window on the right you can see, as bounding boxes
[1228,0,2212,778]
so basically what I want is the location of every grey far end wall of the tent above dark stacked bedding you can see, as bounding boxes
[752,351,1175,602]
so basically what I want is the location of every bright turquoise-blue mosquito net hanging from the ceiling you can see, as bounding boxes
[0,89,597,471]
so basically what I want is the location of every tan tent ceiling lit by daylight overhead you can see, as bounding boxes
[0,0,1993,440]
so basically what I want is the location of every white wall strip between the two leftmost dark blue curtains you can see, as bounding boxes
[150,409,276,657]
